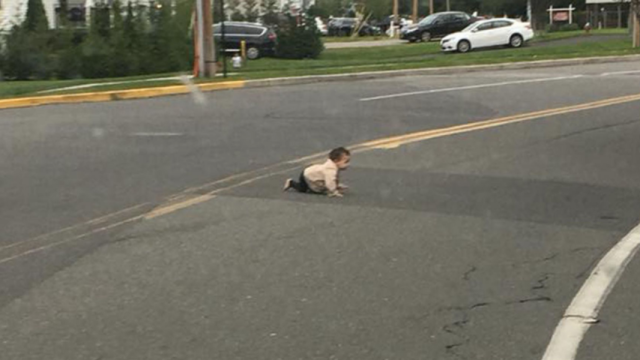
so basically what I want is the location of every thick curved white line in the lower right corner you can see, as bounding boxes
[542,225,640,360]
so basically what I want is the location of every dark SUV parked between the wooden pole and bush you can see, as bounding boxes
[213,21,276,60]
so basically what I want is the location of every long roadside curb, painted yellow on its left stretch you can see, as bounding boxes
[0,55,640,109]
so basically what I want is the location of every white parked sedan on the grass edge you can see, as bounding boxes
[440,19,533,53]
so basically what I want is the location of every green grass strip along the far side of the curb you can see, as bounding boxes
[0,31,640,98]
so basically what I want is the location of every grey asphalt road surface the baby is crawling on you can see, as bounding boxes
[0,63,640,360]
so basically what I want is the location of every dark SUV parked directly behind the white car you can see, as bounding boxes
[400,12,478,42]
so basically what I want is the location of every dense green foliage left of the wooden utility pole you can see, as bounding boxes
[0,0,210,80]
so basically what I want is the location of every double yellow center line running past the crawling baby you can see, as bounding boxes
[0,94,640,264]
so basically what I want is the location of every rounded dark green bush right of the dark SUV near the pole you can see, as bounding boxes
[276,15,324,59]
